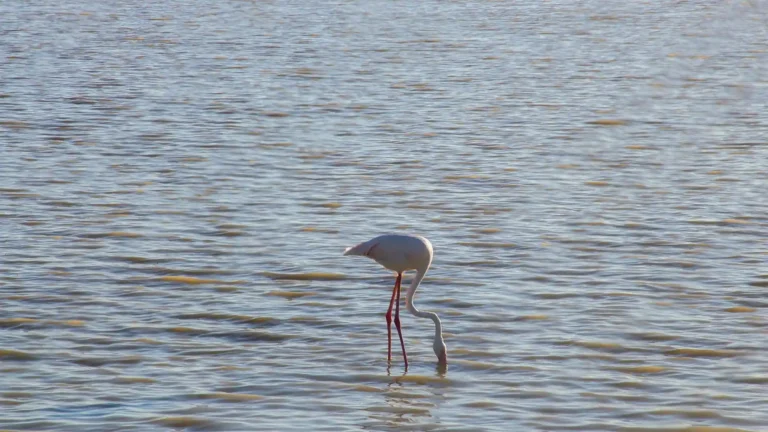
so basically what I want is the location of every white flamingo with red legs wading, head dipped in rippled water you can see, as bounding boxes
[344,234,448,369]
